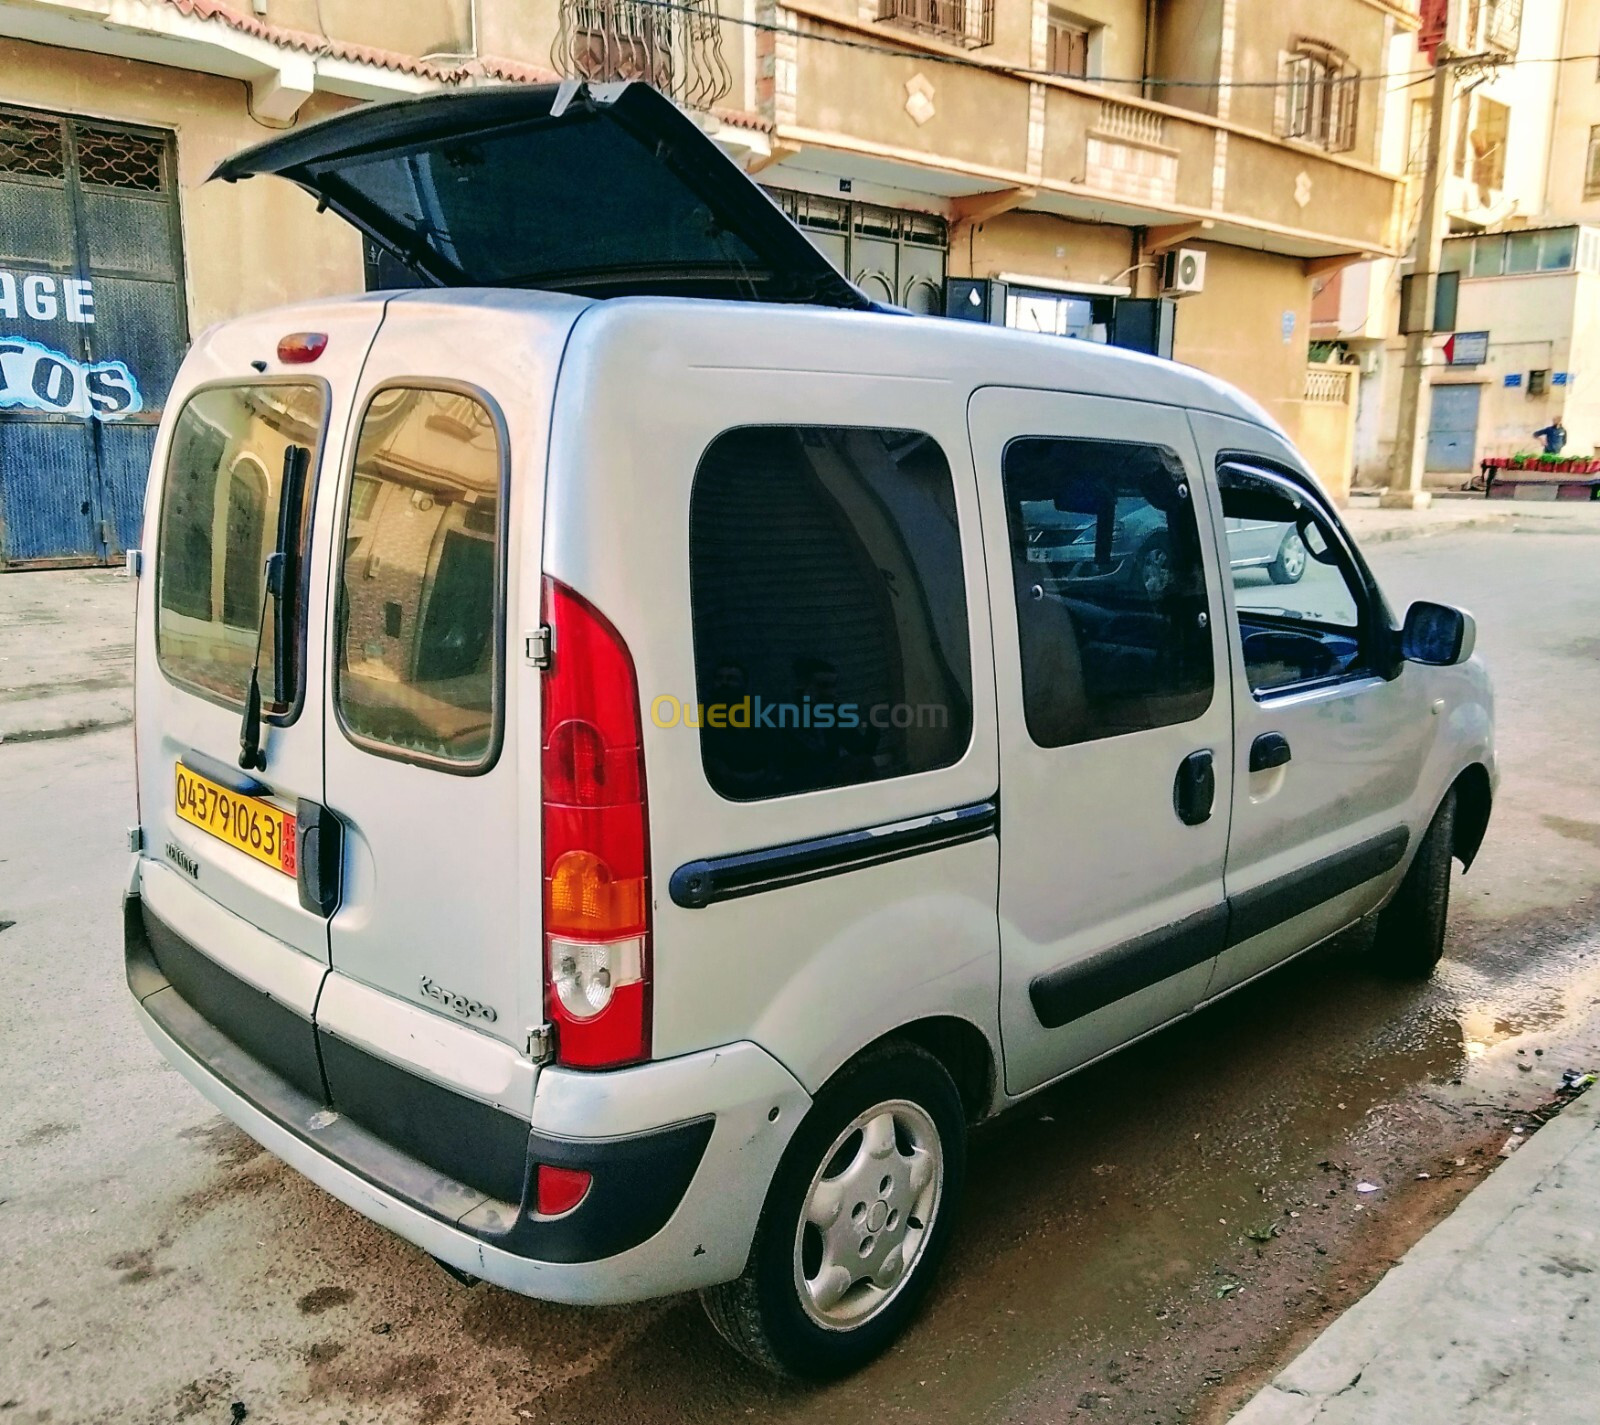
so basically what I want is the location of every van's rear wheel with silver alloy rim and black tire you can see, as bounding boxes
[701,1041,966,1380]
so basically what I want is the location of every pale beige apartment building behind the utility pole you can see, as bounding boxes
[1312,0,1600,489]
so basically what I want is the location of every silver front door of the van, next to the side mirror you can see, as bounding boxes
[1192,406,1432,995]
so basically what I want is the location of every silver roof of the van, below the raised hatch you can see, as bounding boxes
[356,288,1288,428]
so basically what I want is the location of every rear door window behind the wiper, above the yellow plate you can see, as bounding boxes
[155,382,326,718]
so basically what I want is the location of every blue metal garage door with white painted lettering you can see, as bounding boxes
[0,107,187,568]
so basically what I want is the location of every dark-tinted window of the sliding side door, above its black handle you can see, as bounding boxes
[1003,438,1213,747]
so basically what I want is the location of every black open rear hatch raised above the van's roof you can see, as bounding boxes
[213,82,874,309]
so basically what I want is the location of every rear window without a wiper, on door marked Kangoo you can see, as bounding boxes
[334,387,504,769]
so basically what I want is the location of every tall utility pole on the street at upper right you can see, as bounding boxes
[1378,0,1461,510]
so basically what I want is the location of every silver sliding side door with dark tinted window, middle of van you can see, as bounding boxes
[970,390,1234,1094]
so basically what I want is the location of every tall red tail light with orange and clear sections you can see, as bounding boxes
[541,577,650,1068]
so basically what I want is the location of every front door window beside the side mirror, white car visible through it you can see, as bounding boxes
[1218,464,1368,693]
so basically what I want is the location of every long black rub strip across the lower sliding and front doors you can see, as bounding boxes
[1027,827,1411,1028]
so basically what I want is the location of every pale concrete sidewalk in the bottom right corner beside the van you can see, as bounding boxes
[1232,1089,1600,1425]
